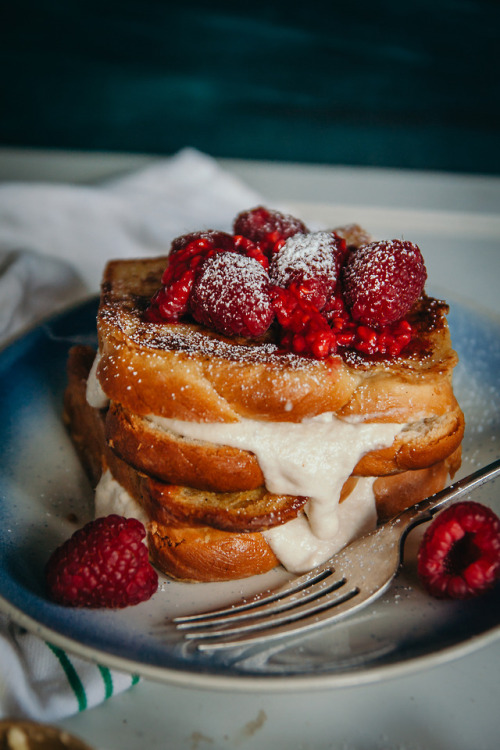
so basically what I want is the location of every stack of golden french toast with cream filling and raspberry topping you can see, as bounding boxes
[64,207,464,582]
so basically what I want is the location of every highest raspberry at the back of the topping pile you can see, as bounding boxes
[233,206,308,255]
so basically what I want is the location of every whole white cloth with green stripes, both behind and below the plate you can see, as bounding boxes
[0,149,260,721]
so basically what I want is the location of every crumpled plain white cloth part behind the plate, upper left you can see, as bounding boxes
[0,148,260,343]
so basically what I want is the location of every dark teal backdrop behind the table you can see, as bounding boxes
[0,0,500,174]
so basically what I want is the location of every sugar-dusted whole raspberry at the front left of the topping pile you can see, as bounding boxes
[190,253,274,338]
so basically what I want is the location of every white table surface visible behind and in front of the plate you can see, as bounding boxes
[0,149,500,750]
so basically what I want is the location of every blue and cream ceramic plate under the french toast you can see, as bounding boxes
[0,300,500,690]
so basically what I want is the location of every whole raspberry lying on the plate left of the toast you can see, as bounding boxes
[45,515,158,609]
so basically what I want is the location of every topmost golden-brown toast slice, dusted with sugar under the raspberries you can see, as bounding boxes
[97,257,458,423]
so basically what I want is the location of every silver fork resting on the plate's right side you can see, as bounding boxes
[173,459,500,651]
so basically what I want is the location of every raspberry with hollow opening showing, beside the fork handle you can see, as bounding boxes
[418,501,500,599]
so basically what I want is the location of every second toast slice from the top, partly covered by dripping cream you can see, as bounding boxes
[105,402,464,492]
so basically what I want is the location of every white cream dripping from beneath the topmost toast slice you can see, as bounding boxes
[150,413,404,540]
